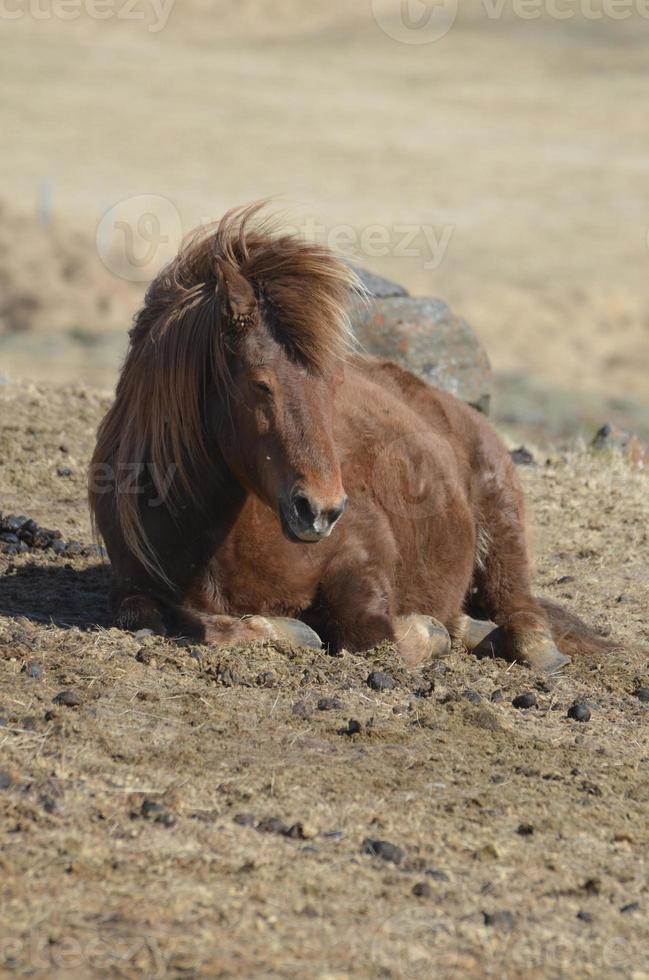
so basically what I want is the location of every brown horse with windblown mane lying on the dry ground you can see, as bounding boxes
[90,207,599,670]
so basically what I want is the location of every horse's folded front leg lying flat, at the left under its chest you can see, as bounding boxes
[115,594,322,650]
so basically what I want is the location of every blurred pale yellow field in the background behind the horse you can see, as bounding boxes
[0,0,649,440]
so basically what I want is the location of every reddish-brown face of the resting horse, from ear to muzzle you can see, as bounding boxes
[219,255,347,542]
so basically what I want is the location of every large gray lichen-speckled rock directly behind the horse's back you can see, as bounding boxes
[351,290,491,413]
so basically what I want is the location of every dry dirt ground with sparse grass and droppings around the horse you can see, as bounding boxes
[0,384,649,980]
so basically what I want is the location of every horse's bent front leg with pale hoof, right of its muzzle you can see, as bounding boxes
[307,556,451,667]
